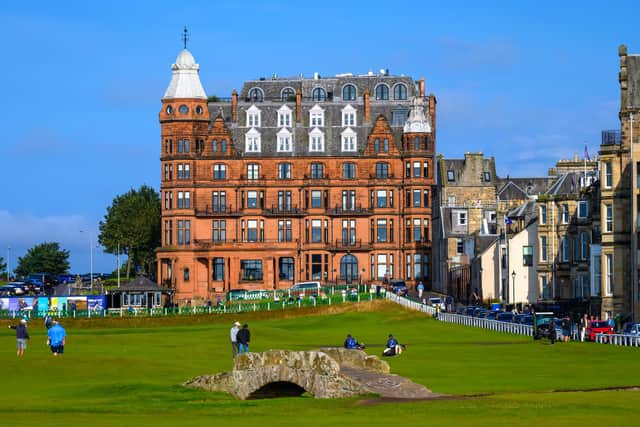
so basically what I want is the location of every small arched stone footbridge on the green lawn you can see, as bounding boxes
[184,348,435,399]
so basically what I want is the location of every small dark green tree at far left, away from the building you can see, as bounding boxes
[15,242,69,276]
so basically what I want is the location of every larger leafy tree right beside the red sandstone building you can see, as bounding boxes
[98,185,161,277]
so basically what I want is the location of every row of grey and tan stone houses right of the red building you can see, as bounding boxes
[433,46,640,320]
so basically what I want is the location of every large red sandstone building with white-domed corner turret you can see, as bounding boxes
[158,49,436,301]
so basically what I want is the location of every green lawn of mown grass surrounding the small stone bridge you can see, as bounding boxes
[0,303,640,427]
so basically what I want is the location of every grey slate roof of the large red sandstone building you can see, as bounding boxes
[209,75,428,158]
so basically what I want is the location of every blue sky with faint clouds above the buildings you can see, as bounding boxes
[0,0,640,272]
